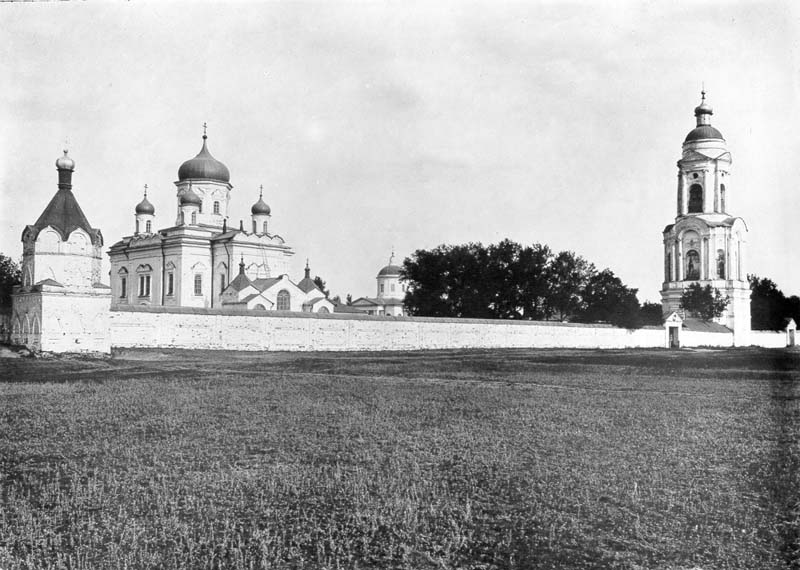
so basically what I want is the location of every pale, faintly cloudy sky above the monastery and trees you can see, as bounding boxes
[0,1,800,301]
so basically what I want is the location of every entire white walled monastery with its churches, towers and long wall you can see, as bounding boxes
[5,93,795,352]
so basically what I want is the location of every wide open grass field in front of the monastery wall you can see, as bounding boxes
[0,350,800,570]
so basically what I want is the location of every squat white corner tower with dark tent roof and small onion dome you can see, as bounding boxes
[11,150,110,352]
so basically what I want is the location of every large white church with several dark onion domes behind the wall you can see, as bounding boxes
[108,130,325,311]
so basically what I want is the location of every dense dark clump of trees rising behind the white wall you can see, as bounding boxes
[403,239,661,328]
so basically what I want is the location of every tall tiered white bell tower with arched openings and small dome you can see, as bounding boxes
[661,91,750,345]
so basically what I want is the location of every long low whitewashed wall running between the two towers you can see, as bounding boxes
[111,306,744,351]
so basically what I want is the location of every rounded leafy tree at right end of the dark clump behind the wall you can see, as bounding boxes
[578,269,641,329]
